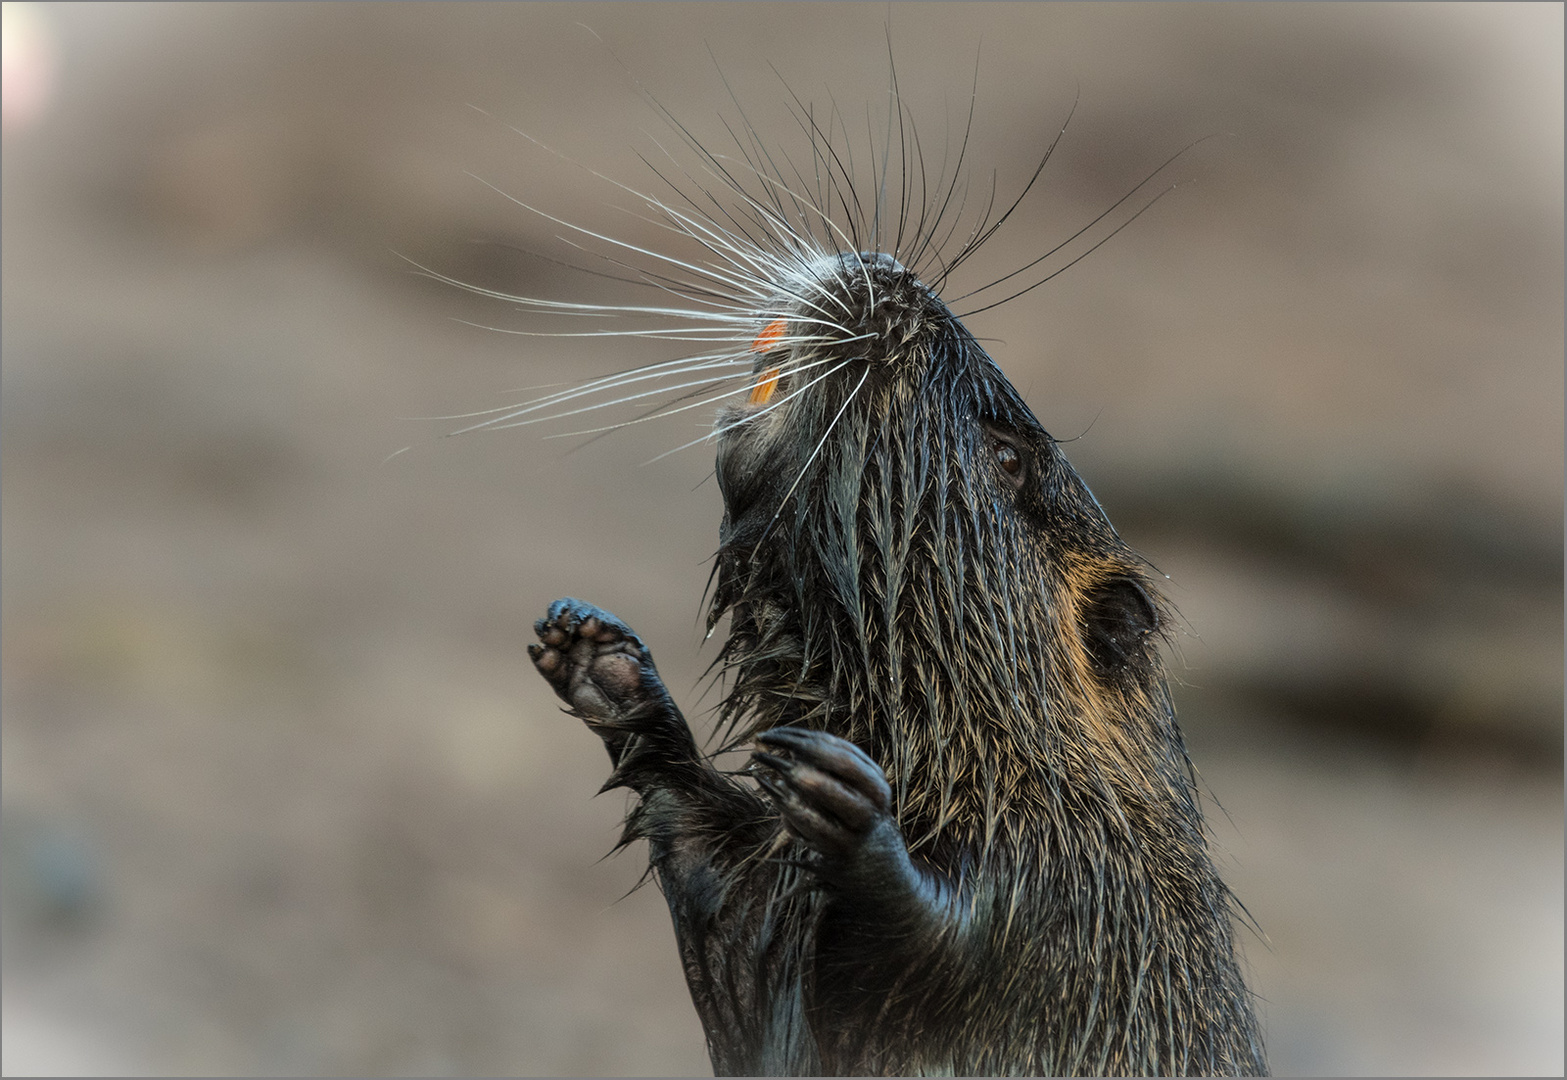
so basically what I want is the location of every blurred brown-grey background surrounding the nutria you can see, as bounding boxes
[0,3,1564,1075]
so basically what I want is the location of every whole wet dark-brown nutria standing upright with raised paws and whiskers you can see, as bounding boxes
[520,79,1266,1075]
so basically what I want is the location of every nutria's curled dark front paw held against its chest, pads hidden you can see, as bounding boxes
[751,727,901,861]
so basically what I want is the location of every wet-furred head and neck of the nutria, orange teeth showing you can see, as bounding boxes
[710,254,1189,846]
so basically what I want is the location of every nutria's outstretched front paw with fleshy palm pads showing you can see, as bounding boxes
[528,597,663,723]
